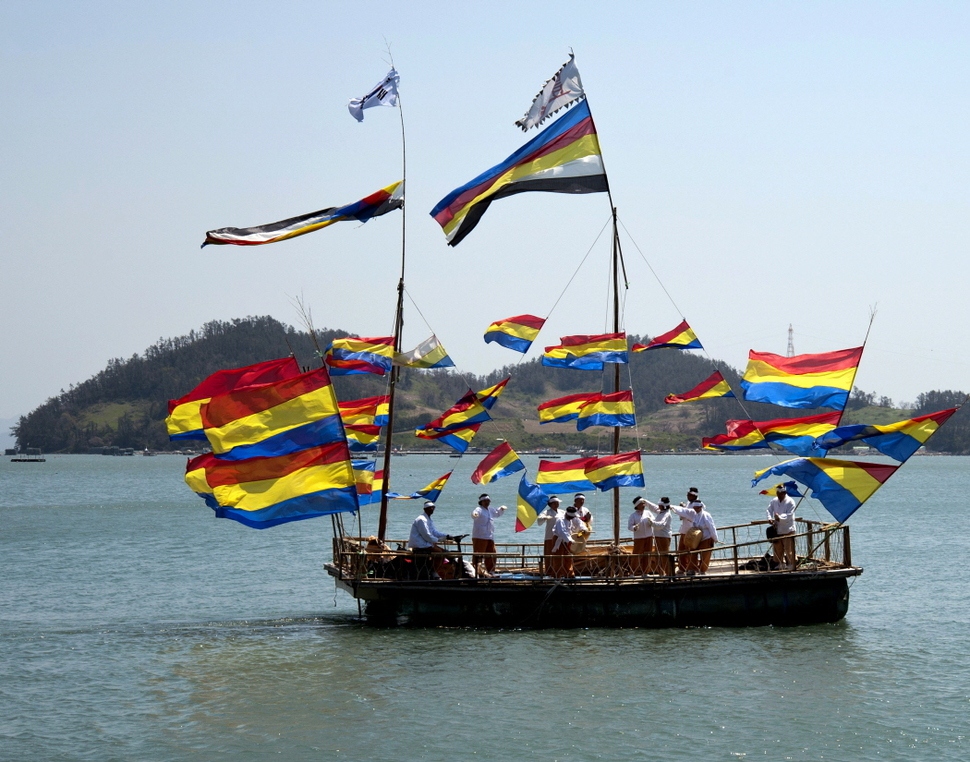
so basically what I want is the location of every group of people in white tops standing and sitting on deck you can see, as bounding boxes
[408,486,797,579]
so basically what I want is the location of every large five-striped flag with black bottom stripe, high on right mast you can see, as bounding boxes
[431,101,607,246]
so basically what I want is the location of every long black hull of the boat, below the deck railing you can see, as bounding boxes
[328,567,862,628]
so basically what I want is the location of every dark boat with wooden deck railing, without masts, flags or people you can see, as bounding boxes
[326,519,862,628]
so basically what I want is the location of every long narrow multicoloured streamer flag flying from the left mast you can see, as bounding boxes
[202,180,404,246]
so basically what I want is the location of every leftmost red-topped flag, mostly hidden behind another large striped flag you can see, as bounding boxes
[165,357,300,442]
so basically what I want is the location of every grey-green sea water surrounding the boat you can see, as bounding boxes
[0,455,970,761]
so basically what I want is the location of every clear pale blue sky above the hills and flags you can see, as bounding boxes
[0,2,970,419]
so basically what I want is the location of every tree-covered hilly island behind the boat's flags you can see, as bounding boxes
[11,317,970,454]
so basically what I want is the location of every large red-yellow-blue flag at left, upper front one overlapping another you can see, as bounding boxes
[201,368,344,460]
